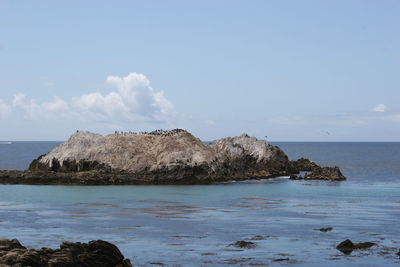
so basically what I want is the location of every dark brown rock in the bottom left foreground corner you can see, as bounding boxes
[0,239,132,267]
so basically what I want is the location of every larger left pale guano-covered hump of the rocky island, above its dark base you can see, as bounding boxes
[40,131,213,172]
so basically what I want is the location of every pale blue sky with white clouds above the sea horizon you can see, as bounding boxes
[0,0,400,141]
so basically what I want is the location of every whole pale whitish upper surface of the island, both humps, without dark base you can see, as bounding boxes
[40,130,279,172]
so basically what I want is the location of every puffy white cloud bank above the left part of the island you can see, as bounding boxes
[0,72,174,123]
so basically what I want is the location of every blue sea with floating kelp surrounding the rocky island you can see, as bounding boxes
[0,142,400,267]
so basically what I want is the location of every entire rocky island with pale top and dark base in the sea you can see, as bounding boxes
[0,129,345,185]
